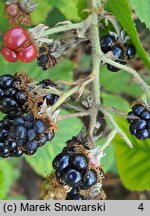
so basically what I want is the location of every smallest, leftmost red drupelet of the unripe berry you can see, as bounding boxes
[1,47,18,62]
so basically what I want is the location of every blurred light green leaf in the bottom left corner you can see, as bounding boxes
[0,159,19,200]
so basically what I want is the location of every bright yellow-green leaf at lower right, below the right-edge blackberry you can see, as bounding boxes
[113,118,150,190]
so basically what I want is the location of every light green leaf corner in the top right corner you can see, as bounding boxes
[129,0,150,29]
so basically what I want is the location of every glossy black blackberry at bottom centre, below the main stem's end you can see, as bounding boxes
[52,145,98,190]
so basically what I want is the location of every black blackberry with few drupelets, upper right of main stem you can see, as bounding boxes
[100,35,136,72]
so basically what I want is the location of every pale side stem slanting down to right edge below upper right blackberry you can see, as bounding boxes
[102,55,150,102]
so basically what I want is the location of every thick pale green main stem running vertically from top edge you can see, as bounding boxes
[88,0,102,147]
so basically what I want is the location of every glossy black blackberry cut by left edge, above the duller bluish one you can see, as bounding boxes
[0,74,27,118]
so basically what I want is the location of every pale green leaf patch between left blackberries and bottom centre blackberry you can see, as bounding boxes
[25,111,82,177]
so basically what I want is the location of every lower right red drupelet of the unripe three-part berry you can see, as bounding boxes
[18,44,38,63]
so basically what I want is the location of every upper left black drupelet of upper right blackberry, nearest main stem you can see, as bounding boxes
[100,35,115,53]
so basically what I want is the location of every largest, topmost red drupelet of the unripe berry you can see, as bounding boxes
[4,27,29,51]
